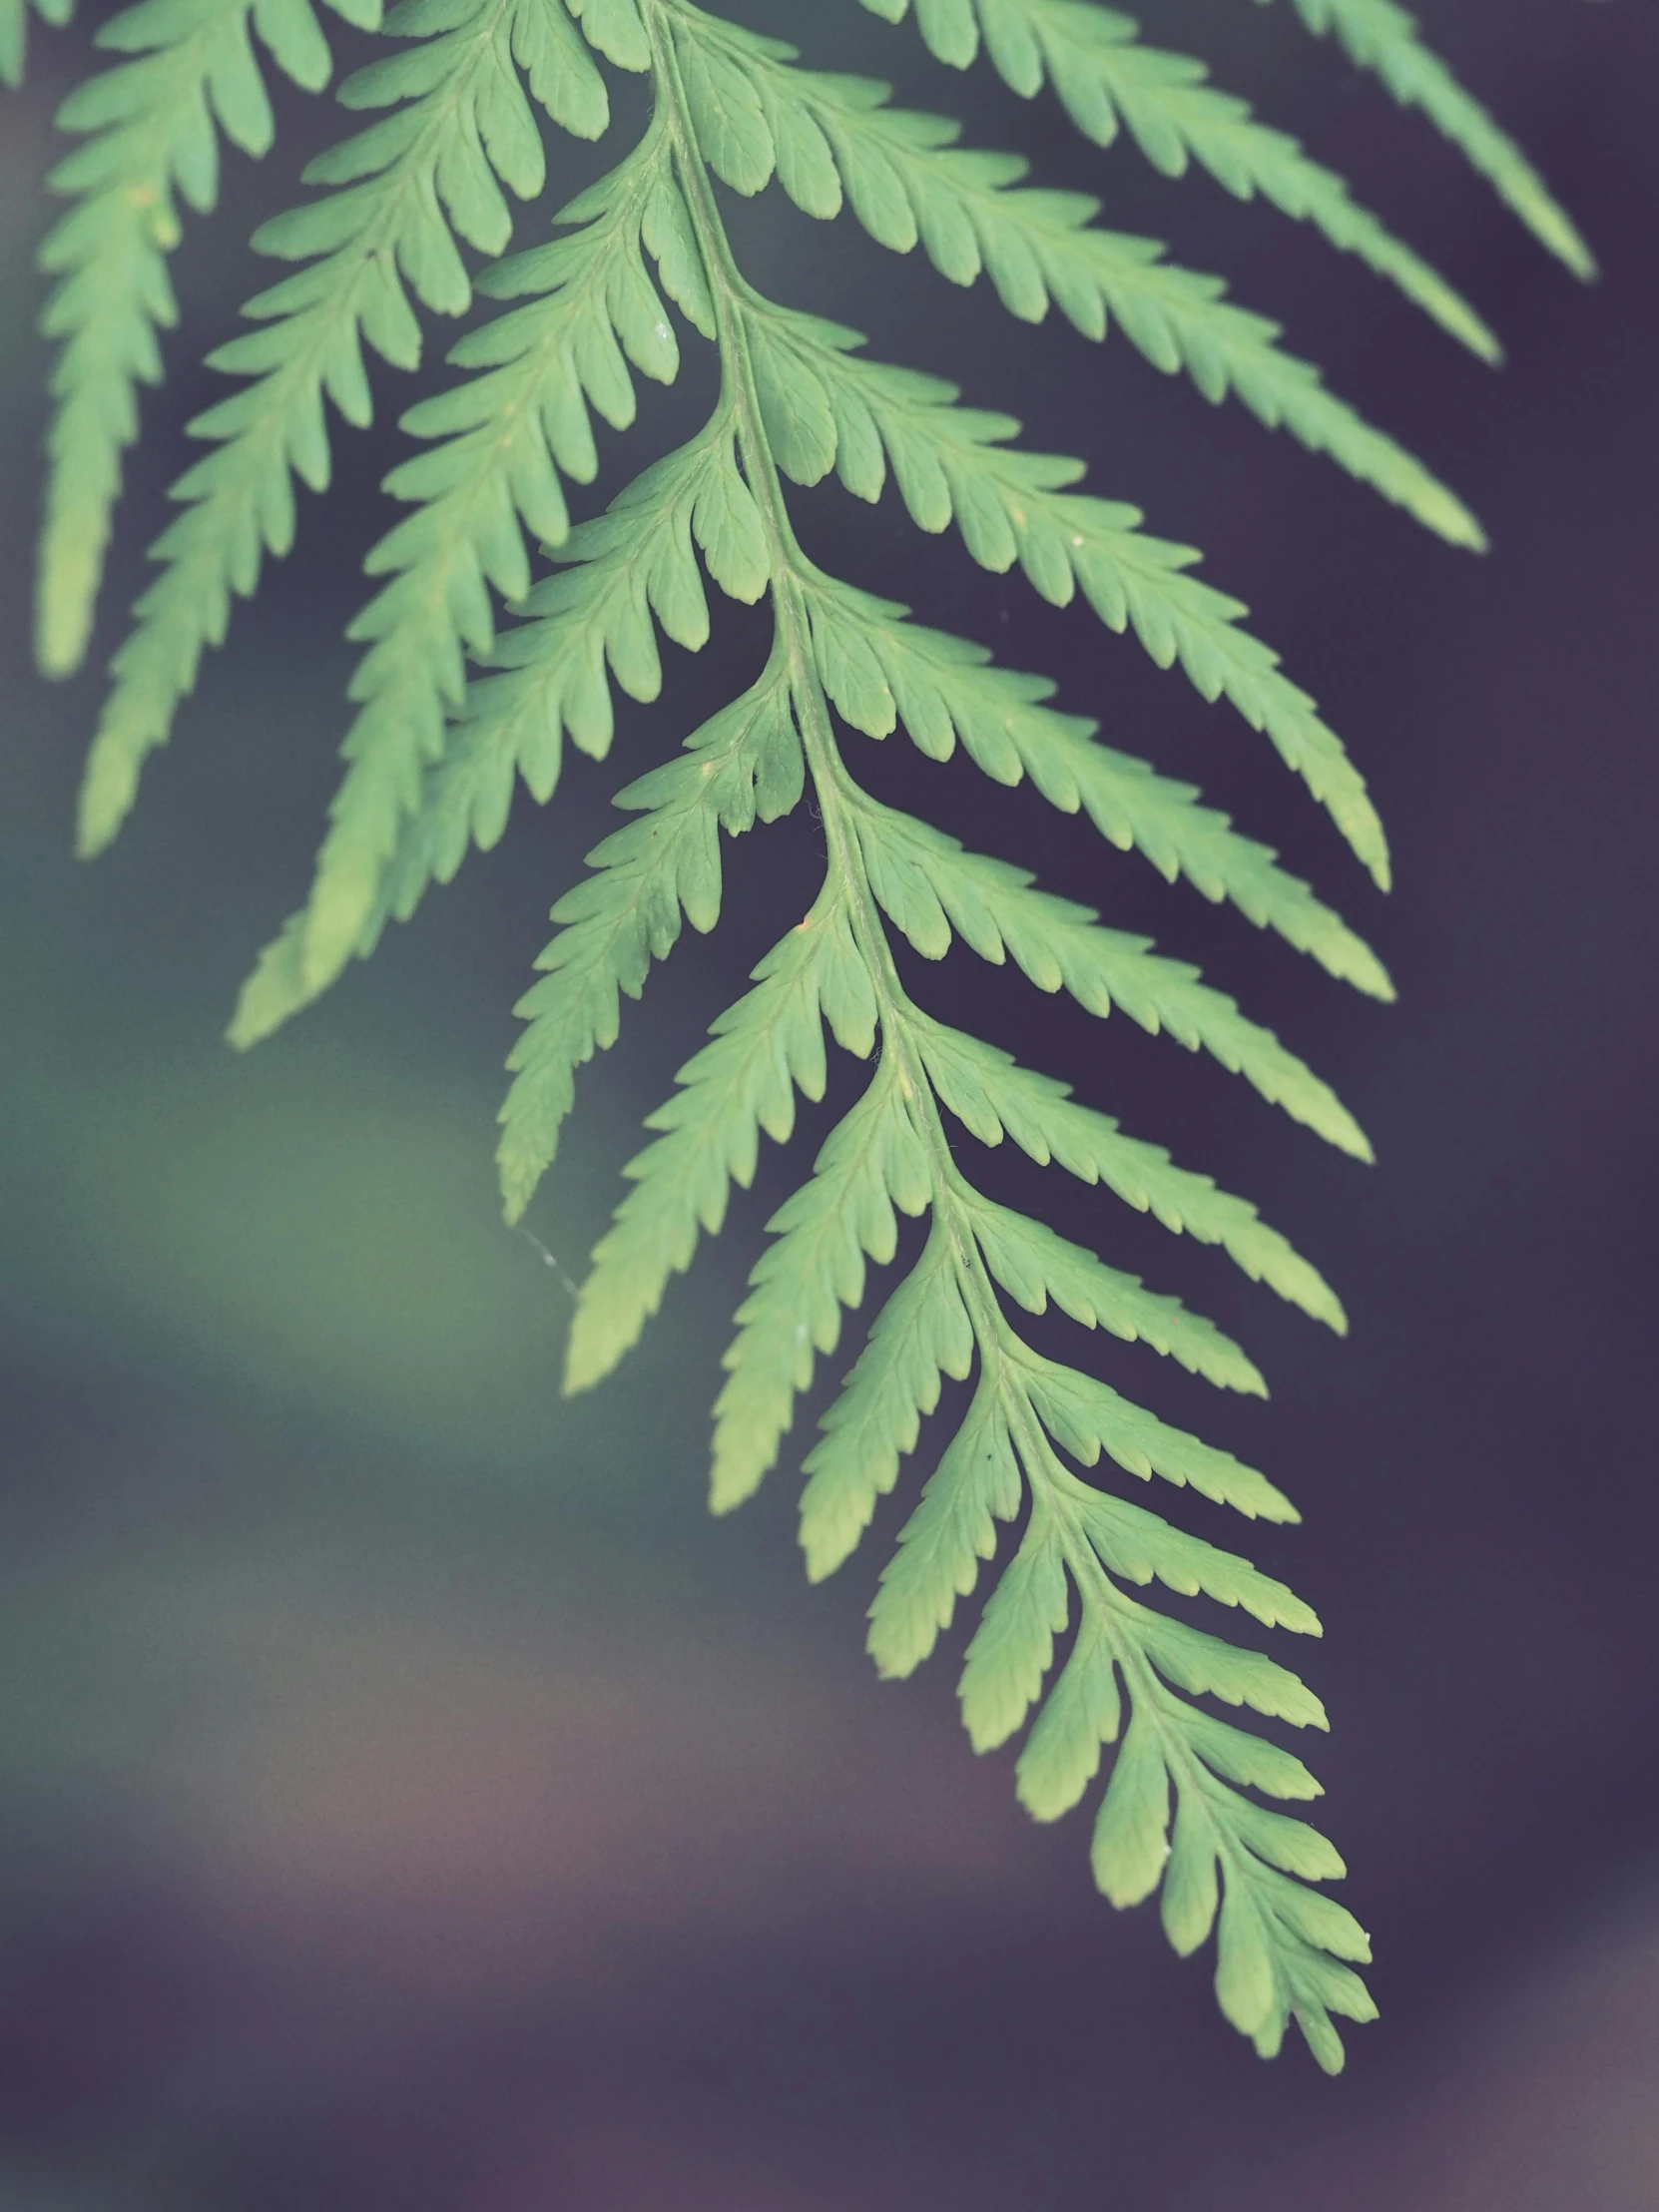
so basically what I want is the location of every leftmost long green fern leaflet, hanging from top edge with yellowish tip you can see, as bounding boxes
[35,0,380,677]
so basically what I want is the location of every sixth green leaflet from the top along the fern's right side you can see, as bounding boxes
[849,792,1372,1159]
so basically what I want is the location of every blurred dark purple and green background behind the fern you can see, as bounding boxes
[0,0,1659,2212]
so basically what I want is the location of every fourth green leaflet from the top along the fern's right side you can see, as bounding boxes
[757,316,1389,889]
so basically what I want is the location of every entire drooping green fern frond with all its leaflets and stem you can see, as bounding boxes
[35,0,1588,2070]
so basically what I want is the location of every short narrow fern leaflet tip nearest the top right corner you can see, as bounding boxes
[1259,0,1595,278]
